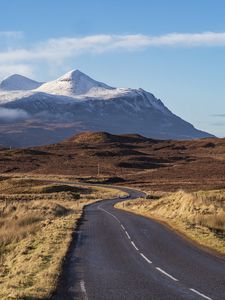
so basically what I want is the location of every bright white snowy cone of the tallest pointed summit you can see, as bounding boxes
[38,70,113,96]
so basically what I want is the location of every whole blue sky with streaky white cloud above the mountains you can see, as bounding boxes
[0,0,225,137]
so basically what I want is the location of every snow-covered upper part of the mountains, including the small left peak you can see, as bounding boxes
[0,70,170,114]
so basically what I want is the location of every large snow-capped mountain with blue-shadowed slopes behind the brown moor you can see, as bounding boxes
[0,70,212,146]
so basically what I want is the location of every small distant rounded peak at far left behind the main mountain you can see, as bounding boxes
[0,74,43,91]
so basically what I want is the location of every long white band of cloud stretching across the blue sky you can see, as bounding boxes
[0,31,225,76]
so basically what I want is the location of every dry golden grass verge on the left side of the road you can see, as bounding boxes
[0,178,125,299]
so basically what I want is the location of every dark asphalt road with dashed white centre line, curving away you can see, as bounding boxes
[53,189,225,300]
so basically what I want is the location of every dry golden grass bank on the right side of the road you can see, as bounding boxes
[115,190,225,255]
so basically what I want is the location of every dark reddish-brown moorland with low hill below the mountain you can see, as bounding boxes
[0,132,225,191]
